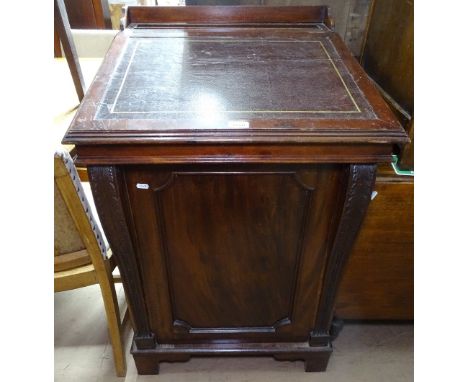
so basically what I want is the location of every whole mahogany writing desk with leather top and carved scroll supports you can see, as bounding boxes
[64,7,407,374]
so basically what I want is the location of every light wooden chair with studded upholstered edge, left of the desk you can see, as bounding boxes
[54,150,127,377]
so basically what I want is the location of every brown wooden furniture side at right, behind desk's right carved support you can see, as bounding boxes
[336,170,414,320]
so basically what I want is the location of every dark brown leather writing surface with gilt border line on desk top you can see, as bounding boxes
[95,30,376,122]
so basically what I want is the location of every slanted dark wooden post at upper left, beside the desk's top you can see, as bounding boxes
[54,0,85,101]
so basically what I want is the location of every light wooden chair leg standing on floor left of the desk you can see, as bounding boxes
[99,268,127,377]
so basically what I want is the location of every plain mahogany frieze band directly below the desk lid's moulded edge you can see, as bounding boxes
[76,144,391,166]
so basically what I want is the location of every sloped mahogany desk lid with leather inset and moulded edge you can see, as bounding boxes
[63,24,407,144]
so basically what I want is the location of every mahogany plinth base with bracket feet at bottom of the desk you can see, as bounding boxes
[131,342,332,375]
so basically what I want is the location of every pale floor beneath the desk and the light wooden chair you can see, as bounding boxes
[55,285,413,382]
